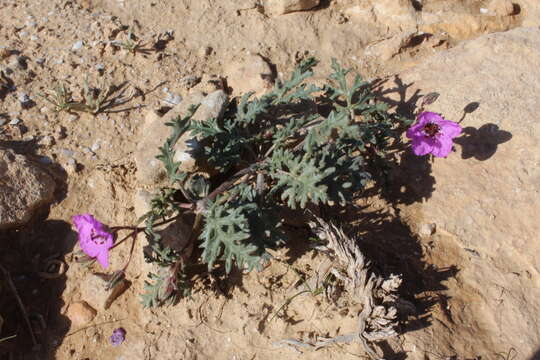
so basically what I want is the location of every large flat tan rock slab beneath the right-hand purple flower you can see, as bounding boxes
[391,28,540,359]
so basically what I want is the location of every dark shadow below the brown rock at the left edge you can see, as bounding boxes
[0,220,77,360]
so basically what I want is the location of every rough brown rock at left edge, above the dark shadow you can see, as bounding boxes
[0,149,55,230]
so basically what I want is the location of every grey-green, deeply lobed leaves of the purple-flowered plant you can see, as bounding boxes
[140,58,410,305]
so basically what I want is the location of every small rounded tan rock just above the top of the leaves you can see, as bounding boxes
[225,55,274,95]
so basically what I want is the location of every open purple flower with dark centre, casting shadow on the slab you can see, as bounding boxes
[407,111,461,157]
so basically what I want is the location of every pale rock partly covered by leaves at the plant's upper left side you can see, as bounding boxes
[135,90,227,186]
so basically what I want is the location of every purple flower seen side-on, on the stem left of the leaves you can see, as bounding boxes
[72,214,114,268]
